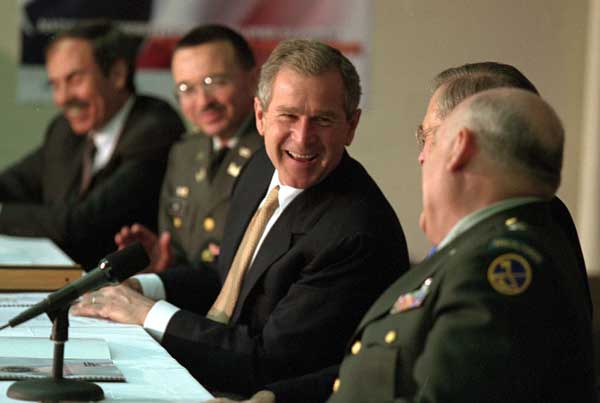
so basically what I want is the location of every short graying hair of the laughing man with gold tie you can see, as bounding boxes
[256,39,361,119]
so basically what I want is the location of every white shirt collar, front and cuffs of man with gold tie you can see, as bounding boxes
[135,170,304,341]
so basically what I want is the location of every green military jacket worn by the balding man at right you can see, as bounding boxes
[330,202,595,403]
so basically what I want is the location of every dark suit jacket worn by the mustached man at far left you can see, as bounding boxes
[0,96,184,268]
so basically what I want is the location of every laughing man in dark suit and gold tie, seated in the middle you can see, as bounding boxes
[71,40,408,394]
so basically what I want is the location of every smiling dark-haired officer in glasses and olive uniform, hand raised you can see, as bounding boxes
[116,25,263,271]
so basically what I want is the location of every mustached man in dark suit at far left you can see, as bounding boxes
[0,23,183,268]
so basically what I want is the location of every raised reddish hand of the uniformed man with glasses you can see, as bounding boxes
[115,224,173,273]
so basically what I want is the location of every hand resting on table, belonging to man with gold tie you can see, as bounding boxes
[71,285,154,325]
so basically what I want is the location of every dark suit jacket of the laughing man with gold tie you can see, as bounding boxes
[162,149,408,393]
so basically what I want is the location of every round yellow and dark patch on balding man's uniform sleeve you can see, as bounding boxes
[487,253,532,295]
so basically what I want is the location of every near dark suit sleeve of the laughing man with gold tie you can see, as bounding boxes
[163,234,397,393]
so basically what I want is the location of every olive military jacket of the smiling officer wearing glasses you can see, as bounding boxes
[159,118,263,267]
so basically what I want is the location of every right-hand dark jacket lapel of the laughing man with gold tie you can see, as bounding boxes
[232,154,350,321]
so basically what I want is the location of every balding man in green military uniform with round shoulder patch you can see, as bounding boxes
[330,89,595,402]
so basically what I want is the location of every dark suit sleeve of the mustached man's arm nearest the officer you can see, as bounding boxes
[0,160,164,261]
